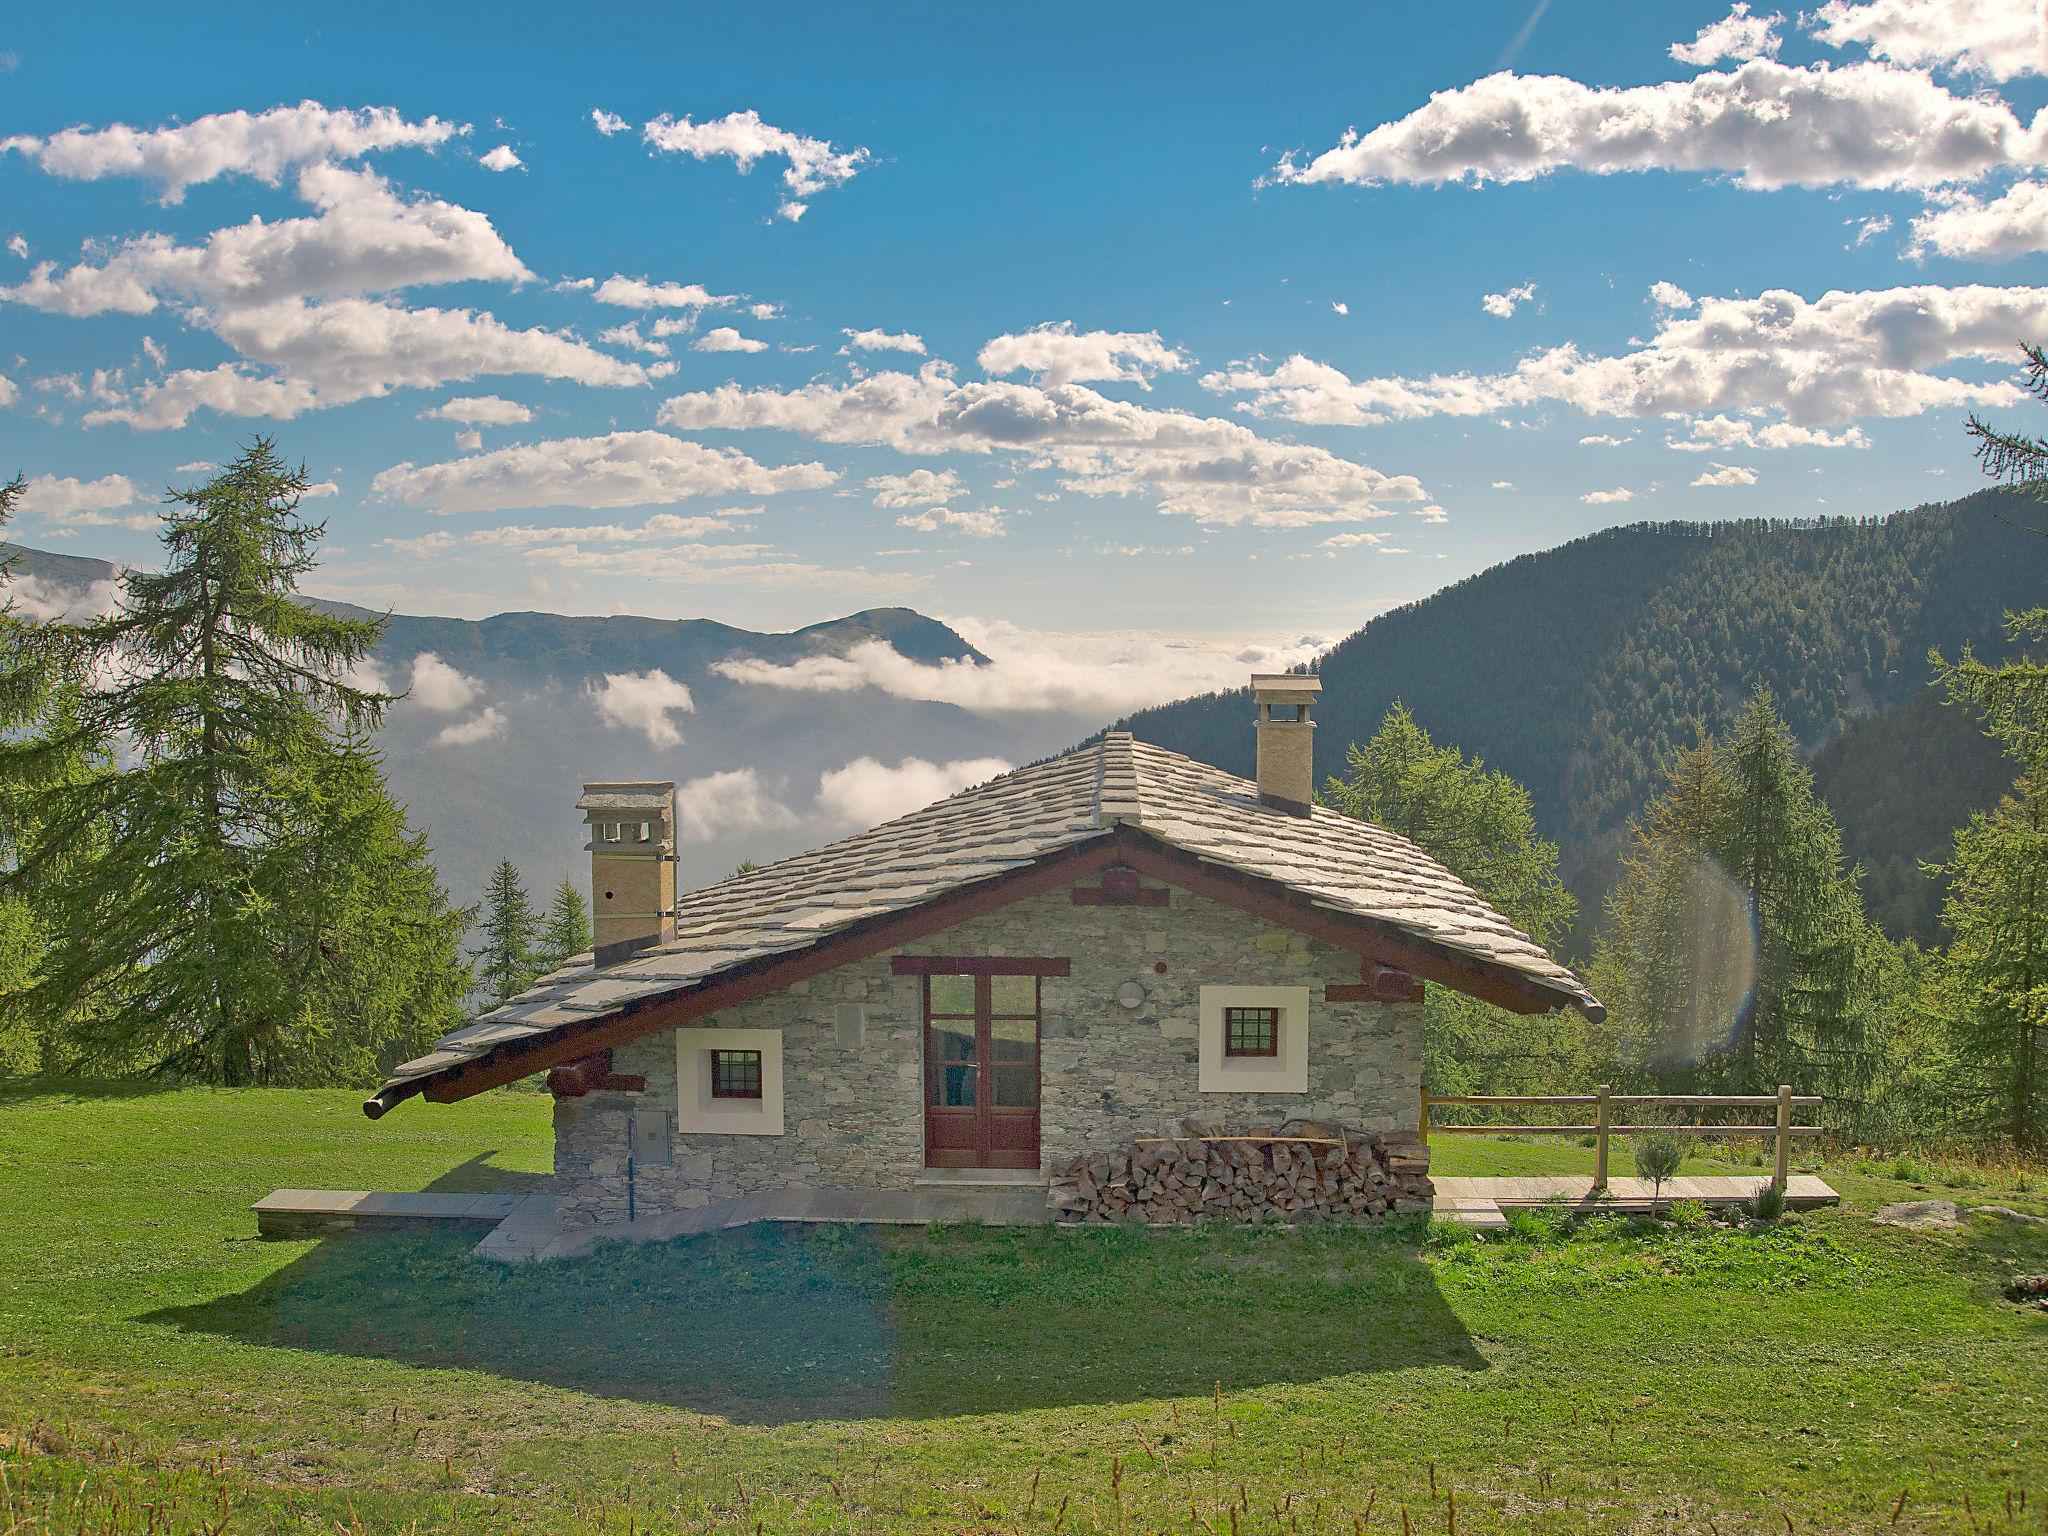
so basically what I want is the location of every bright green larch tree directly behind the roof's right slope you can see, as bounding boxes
[1321,702,1585,1094]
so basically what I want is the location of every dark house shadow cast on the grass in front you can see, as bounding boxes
[143,1225,1485,1423]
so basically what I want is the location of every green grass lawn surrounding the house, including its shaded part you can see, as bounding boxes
[0,1087,2048,1536]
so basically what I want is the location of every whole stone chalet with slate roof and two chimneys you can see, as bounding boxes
[376,676,1602,1235]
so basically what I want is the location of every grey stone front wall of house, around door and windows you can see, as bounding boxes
[555,889,1421,1223]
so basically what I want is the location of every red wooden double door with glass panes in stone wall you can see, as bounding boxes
[924,975,1038,1167]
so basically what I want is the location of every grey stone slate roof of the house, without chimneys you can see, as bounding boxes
[385,731,1602,1087]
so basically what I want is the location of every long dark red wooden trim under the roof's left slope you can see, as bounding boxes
[413,831,1118,1114]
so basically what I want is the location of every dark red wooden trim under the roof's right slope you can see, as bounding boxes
[1118,827,1571,1014]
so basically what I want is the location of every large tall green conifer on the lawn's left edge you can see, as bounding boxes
[0,438,463,1083]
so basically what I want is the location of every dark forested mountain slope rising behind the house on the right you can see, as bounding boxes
[1128,492,2048,933]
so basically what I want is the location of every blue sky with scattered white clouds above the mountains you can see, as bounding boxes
[0,0,2048,684]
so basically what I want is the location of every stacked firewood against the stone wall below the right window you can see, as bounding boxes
[1049,1120,1436,1223]
